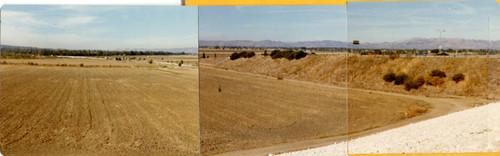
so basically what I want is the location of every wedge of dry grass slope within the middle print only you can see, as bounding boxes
[216,55,347,86]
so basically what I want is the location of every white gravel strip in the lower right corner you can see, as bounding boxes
[281,102,500,156]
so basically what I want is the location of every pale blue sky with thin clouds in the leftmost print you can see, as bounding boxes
[1,5,198,50]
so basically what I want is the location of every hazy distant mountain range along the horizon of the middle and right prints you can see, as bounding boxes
[199,38,500,49]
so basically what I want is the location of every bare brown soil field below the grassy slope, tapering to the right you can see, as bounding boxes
[200,65,446,155]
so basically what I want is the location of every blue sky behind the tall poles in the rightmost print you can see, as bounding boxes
[347,0,500,42]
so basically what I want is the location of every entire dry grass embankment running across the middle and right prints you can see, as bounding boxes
[212,55,492,98]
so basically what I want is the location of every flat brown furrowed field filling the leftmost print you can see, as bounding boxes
[0,57,199,155]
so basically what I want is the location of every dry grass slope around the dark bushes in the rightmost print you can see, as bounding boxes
[348,56,488,97]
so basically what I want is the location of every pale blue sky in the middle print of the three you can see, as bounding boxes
[199,5,346,41]
